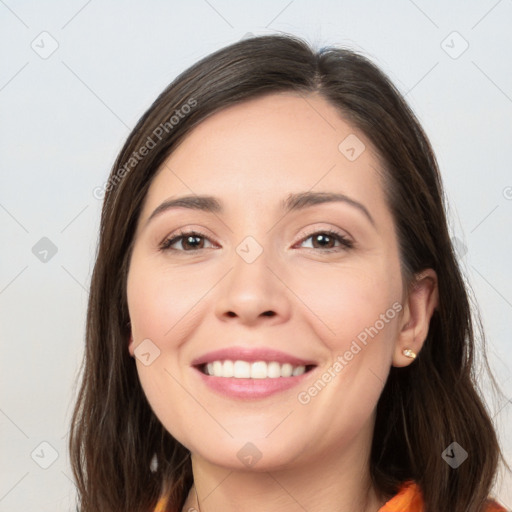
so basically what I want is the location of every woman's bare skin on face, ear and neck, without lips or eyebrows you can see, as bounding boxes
[128,93,438,512]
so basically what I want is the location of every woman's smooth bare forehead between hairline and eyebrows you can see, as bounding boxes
[142,92,383,216]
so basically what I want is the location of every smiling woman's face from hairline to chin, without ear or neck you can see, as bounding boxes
[128,93,403,470]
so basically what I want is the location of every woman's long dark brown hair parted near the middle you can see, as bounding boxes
[69,35,510,512]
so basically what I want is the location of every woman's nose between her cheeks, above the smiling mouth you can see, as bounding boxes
[215,242,291,326]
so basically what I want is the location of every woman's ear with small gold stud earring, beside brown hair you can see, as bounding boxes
[393,268,439,367]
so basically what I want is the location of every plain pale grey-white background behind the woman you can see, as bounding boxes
[0,0,512,512]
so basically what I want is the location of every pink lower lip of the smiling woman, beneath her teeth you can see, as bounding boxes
[194,368,315,399]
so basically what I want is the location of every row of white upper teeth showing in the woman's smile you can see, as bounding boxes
[205,360,306,379]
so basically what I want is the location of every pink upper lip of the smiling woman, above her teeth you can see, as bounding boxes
[192,346,316,366]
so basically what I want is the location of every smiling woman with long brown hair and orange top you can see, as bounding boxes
[70,35,510,512]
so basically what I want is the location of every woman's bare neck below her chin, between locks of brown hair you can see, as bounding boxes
[183,426,385,512]
